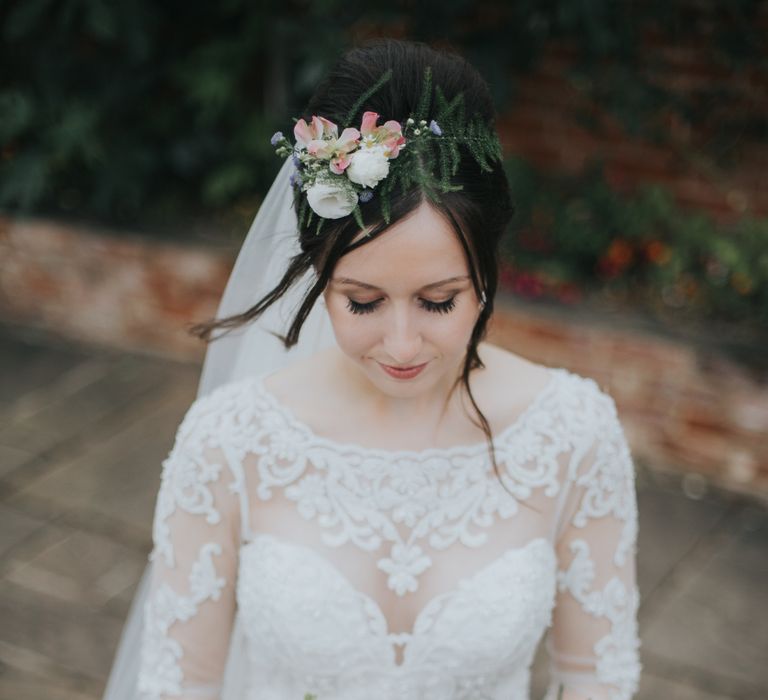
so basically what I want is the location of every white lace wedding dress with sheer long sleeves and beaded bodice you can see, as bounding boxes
[138,368,640,700]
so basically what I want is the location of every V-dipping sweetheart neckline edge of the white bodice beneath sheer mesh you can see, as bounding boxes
[240,532,557,671]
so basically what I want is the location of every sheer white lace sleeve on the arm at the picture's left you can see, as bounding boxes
[138,403,240,700]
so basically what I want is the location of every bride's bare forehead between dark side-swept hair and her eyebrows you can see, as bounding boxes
[333,202,469,289]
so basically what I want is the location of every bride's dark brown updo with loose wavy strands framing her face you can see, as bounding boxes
[190,39,514,492]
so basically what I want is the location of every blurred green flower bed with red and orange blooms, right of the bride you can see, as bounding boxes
[503,159,768,324]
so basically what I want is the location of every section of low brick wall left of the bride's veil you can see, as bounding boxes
[0,218,233,358]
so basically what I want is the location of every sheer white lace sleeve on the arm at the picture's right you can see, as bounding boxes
[545,383,640,700]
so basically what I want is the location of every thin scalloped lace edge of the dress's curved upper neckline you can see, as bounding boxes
[254,367,567,460]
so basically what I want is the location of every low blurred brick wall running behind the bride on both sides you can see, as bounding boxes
[0,219,768,500]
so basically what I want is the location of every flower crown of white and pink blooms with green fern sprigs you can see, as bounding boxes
[270,66,502,234]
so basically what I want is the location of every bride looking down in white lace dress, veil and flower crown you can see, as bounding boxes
[105,39,640,700]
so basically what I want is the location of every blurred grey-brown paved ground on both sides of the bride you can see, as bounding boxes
[0,327,768,700]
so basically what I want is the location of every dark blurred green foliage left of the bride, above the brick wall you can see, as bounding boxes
[0,0,364,228]
